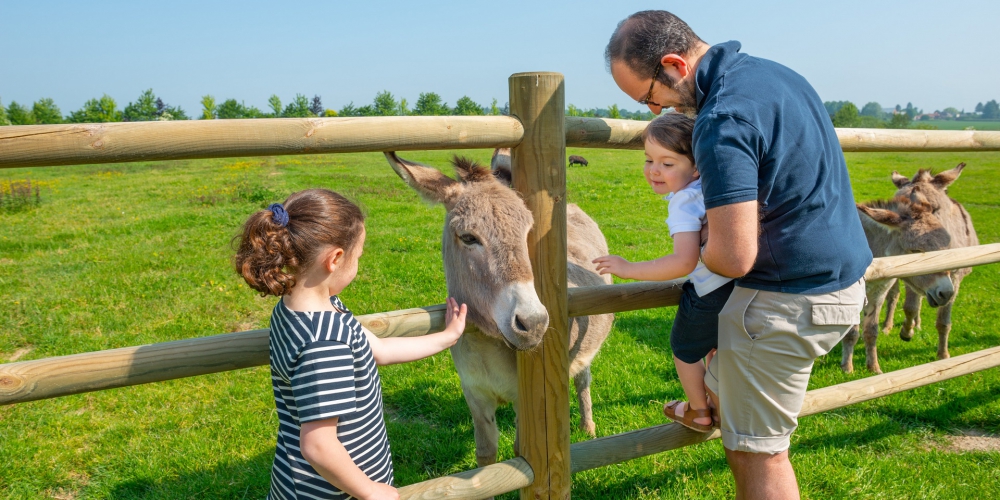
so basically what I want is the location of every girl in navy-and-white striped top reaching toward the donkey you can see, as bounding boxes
[234,189,466,499]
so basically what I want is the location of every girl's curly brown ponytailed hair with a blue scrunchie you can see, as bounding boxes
[233,189,365,297]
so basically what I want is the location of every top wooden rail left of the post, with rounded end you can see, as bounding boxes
[0,116,524,168]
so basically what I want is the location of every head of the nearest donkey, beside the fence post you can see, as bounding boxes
[385,152,549,350]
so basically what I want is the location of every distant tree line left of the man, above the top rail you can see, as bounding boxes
[0,89,654,125]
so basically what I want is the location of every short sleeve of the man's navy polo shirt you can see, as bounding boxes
[693,114,765,209]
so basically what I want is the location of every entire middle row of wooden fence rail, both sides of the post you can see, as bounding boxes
[0,243,1000,405]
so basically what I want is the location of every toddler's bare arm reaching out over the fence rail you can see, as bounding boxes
[593,231,701,281]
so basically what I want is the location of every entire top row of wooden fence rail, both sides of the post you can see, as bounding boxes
[0,116,1000,168]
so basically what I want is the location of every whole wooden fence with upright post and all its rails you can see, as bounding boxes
[0,73,1000,499]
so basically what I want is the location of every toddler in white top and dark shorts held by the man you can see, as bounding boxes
[594,113,733,432]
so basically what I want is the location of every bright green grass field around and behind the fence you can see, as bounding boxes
[0,150,1000,499]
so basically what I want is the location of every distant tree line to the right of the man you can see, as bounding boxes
[823,99,1000,128]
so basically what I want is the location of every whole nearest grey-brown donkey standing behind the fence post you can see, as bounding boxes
[385,150,614,466]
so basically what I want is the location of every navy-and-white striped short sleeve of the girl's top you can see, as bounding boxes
[290,342,357,424]
